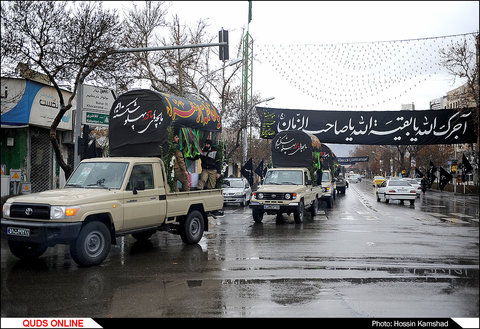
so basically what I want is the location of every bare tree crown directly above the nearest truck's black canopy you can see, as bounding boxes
[126,1,214,97]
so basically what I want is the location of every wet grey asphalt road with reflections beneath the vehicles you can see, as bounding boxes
[1,181,479,318]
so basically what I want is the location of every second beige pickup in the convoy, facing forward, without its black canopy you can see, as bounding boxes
[250,168,323,223]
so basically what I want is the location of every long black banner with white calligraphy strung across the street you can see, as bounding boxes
[257,107,476,145]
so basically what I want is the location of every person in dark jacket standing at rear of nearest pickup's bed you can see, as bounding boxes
[194,139,221,190]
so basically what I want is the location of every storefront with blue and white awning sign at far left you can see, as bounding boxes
[1,78,75,196]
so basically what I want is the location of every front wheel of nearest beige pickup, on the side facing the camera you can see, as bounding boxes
[70,221,112,266]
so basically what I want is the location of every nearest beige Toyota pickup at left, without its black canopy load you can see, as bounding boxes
[1,157,223,266]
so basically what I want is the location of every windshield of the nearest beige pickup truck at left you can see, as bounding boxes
[65,162,128,189]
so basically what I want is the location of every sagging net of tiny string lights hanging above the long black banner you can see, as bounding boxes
[255,32,476,109]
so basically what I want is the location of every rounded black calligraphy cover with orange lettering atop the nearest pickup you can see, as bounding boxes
[109,89,222,156]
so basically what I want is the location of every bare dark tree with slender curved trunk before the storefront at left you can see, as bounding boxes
[1,1,127,178]
